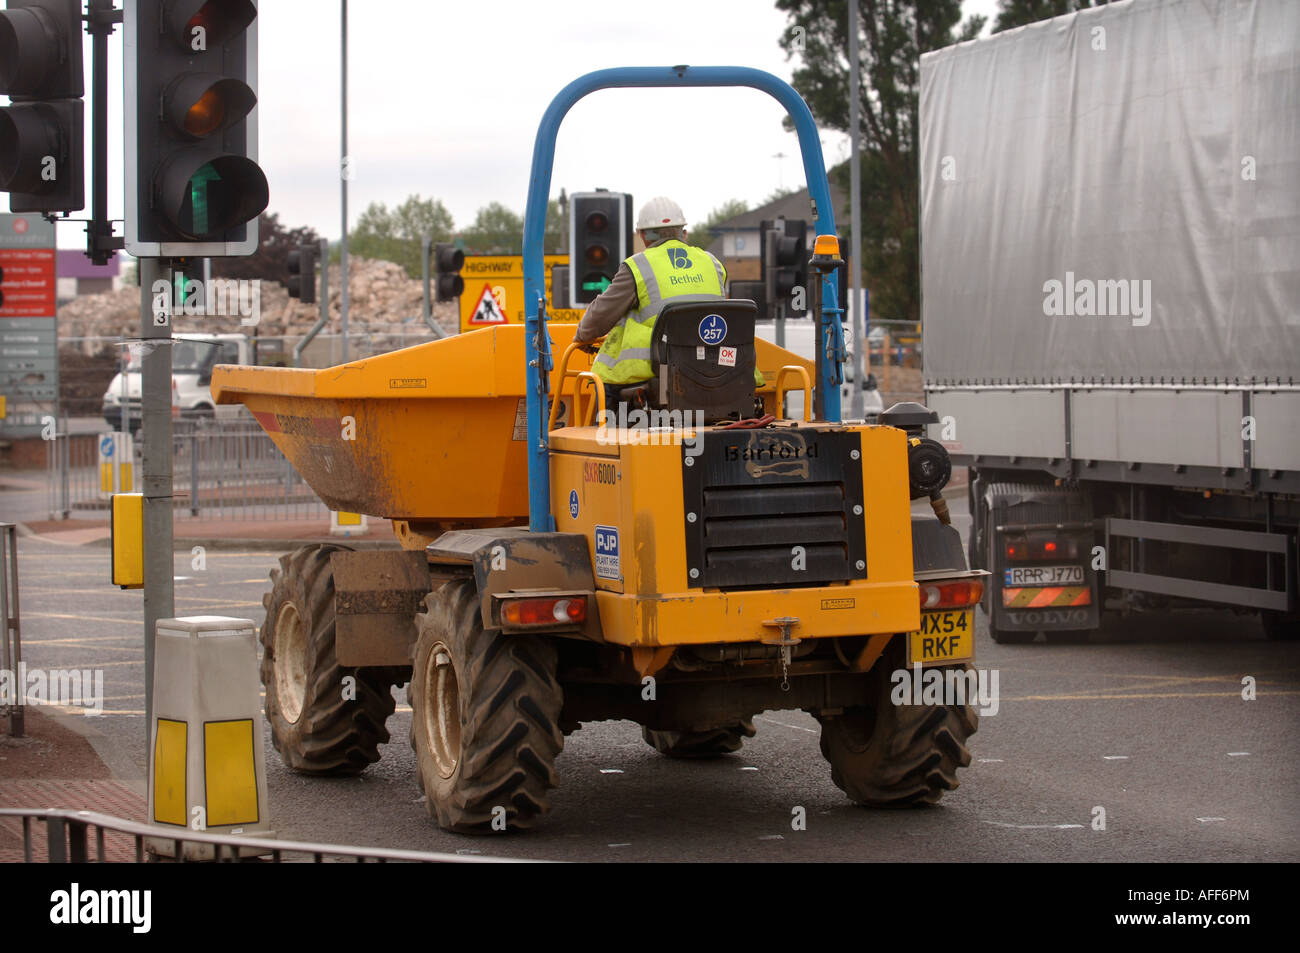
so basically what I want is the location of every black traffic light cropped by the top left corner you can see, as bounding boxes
[0,0,86,213]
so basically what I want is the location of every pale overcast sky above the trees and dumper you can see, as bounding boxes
[0,0,997,247]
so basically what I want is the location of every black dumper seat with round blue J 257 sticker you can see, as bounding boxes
[623,299,758,423]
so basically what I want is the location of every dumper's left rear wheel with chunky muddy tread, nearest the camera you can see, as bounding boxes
[410,581,564,833]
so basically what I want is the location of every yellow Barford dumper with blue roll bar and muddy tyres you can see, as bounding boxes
[212,68,987,832]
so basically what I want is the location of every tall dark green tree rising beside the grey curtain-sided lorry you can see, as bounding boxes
[776,0,985,321]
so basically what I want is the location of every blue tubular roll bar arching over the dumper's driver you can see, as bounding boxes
[524,66,842,533]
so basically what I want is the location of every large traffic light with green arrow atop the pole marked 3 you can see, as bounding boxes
[125,0,269,257]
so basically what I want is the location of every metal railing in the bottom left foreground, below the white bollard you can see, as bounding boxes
[0,807,522,863]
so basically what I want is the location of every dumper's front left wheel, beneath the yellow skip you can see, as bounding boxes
[261,543,395,775]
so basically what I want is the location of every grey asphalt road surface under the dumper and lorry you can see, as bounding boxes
[12,503,1300,862]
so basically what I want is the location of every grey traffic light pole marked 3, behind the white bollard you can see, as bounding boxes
[140,259,176,750]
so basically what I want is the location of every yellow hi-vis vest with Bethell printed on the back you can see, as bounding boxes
[592,239,727,385]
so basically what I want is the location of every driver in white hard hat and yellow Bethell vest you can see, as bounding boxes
[573,195,757,411]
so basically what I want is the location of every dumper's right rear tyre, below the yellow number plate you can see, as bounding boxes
[814,638,979,807]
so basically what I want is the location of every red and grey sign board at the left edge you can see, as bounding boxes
[0,212,59,438]
